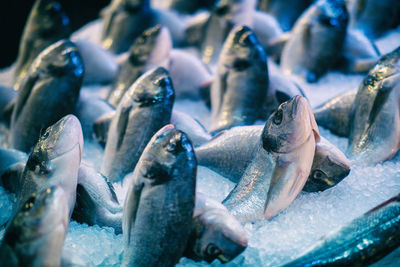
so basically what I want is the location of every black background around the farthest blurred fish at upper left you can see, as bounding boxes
[0,0,110,68]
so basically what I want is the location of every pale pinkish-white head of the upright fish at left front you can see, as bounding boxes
[25,115,83,181]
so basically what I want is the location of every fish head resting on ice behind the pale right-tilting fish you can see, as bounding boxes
[303,138,350,192]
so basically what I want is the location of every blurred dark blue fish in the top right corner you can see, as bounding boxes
[348,0,400,39]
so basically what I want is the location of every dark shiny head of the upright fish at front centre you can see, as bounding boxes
[140,124,196,184]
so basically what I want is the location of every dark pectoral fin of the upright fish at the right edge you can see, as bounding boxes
[368,74,400,128]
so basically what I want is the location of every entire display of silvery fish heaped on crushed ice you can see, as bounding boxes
[0,0,400,266]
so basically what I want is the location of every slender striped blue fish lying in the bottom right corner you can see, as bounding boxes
[283,195,400,267]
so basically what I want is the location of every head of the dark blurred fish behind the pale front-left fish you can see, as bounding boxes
[33,40,84,78]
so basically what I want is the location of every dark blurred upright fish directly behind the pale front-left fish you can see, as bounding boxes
[9,40,84,152]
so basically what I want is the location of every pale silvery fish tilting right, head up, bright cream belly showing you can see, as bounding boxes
[222,96,320,223]
